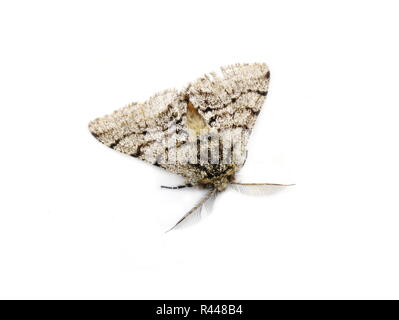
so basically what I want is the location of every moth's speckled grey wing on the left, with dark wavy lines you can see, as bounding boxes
[89,89,187,165]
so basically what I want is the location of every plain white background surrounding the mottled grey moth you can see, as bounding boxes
[0,0,399,299]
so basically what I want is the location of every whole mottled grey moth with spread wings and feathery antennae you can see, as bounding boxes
[89,63,292,229]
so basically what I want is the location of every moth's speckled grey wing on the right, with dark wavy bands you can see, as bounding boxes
[183,63,270,165]
